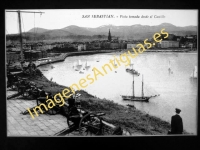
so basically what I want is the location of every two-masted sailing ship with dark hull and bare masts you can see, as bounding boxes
[121,64,157,102]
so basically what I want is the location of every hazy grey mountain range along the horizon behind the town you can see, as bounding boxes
[9,23,197,40]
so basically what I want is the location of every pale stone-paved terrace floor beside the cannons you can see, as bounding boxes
[7,90,73,136]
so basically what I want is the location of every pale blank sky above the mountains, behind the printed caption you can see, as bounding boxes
[5,9,198,34]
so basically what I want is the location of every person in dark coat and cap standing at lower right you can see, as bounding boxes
[168,108,183,134]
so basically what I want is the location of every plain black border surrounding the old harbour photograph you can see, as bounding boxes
[0,0,200,150]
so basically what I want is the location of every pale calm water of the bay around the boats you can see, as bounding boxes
[41,53,197,134]
